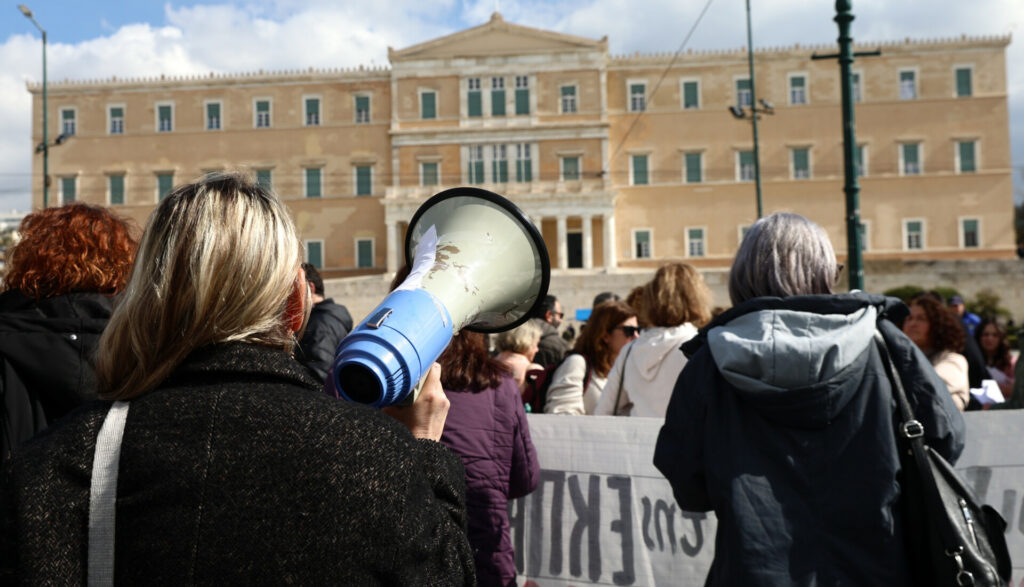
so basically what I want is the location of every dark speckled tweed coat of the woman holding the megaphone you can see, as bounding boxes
[0,342,474,585]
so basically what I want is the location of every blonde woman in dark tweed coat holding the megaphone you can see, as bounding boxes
[0,174,473,585]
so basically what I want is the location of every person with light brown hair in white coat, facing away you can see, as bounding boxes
[594,263,711,418]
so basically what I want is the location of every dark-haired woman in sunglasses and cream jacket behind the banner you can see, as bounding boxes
[544,301,640,415]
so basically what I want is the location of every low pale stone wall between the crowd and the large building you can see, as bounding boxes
[325,259,1024,322]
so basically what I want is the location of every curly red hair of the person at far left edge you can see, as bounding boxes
[4,202,138,300]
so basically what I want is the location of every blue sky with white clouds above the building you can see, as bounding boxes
[0,0,1024,212]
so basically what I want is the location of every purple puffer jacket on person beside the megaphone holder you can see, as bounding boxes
[441,377,541,587]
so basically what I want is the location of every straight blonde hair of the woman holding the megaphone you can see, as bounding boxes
[96,173,310,400]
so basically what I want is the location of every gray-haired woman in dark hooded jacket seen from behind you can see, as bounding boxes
[654,213,964,585]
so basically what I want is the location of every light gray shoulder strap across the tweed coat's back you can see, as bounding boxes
[88,402,128,587]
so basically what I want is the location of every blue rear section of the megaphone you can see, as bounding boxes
[331,289,453,407]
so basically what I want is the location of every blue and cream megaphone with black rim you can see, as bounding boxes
[327,187,551,407]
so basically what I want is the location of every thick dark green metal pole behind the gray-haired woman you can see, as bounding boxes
[835,0,864,290]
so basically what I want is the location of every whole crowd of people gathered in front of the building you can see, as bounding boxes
[0,173,1011,585]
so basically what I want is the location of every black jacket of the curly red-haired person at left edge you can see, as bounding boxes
[0,290,112,466]
